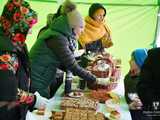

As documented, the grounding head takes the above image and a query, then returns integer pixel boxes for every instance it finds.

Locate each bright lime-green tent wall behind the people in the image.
[0,0,160,74]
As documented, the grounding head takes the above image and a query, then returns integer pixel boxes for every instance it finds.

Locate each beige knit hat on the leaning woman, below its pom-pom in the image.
[67,10,84,28]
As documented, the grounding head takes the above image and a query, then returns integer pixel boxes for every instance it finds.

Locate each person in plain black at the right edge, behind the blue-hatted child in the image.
[137,48,160,120]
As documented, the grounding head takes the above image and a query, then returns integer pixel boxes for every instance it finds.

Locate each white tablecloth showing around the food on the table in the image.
[26,78,132,120]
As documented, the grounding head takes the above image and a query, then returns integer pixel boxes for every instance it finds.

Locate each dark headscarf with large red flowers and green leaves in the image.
[0,0,37,46]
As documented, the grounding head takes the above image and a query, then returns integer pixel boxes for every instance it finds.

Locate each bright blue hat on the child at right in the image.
[132,49,147,68]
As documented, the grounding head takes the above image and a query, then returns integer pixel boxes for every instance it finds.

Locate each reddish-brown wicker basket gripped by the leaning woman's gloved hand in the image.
[88,54,121,91]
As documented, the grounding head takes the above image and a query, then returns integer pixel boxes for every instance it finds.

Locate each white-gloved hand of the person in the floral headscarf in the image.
[34,92,49,109]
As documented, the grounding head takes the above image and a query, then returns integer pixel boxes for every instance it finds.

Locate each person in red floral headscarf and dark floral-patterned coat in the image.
[0,0,48,120]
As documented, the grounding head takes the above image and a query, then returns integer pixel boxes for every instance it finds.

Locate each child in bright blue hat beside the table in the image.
[124,49,149,120]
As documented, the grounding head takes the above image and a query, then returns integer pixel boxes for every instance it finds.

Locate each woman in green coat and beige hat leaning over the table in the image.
[30,1,96,97]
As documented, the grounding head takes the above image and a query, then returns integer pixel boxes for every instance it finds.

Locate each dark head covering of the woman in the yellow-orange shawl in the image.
[89,3,106,18]
